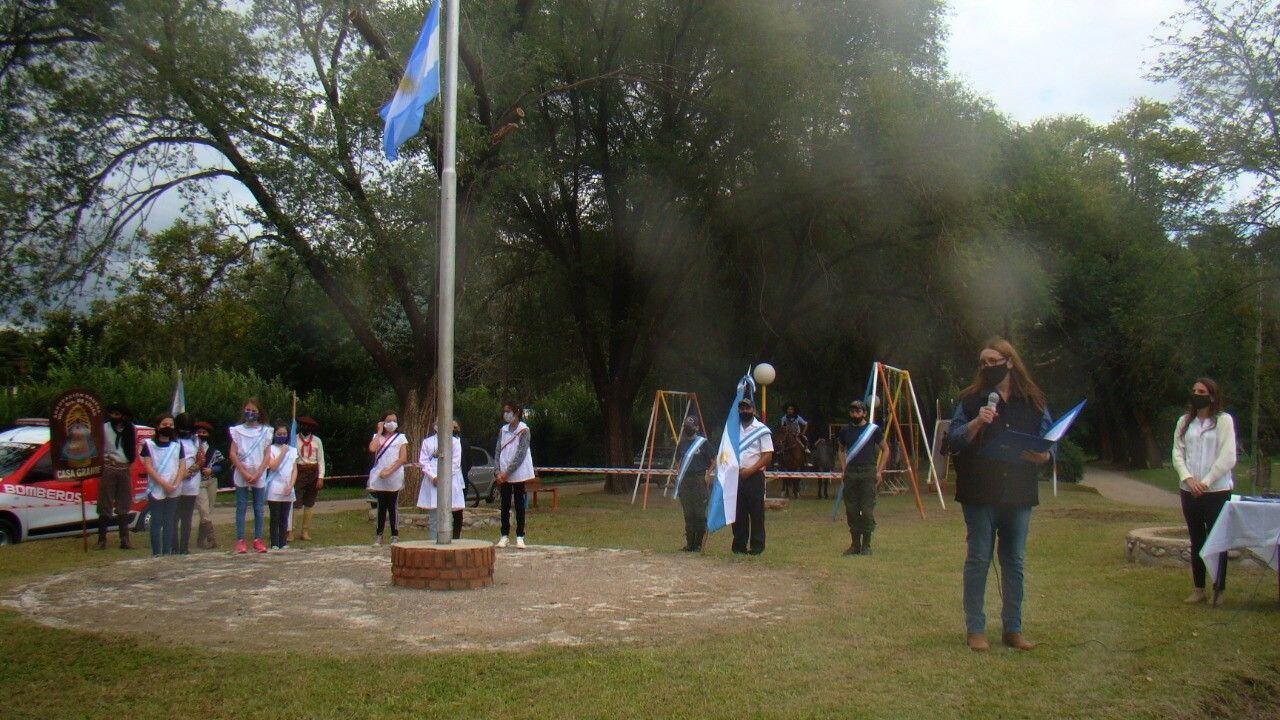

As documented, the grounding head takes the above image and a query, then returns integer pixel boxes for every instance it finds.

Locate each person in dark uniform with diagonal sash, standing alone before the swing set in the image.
[838,400,888,555]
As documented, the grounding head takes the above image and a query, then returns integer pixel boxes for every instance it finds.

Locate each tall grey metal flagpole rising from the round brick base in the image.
[435,0,462,544]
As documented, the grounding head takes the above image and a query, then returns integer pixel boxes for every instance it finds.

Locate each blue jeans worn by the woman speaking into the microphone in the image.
[961,505,1032,634]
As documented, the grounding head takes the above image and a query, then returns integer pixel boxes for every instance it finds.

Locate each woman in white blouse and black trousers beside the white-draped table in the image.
[1174,378,1235,605]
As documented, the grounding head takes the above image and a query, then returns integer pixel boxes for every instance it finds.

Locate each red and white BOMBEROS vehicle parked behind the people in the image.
[0,419,154,544]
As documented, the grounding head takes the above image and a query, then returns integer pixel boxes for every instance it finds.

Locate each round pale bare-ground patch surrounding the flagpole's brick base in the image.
[0,546,810,653]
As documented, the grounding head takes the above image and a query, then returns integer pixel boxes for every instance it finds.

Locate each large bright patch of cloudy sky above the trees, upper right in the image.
[947,0,1184,123]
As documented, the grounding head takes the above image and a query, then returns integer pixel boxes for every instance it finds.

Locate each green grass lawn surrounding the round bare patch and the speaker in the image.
[0,487,1280,720]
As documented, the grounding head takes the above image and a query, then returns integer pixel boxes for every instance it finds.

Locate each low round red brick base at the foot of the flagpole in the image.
[392,539,494,591]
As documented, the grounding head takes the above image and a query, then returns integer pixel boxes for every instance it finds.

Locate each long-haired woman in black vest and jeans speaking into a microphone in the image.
[947,337,1051,651]
